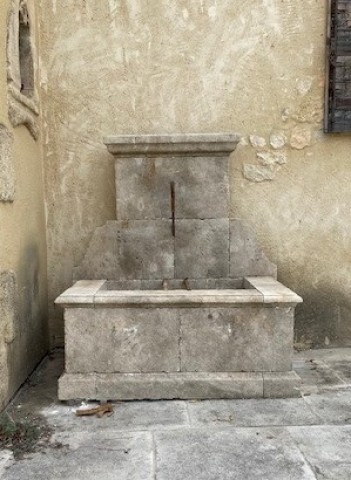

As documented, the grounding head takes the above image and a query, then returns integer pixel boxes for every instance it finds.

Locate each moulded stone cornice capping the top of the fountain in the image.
[103,133,241,157]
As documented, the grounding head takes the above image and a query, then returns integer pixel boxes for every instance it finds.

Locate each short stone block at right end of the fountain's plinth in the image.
[263,372,301,398]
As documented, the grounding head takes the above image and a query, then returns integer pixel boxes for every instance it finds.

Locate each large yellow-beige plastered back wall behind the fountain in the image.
[39,0,351,345]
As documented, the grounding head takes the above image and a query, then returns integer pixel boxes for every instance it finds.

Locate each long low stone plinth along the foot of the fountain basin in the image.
[58,372,300,401]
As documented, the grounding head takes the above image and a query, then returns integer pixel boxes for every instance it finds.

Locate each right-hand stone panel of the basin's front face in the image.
[181,306,294,372]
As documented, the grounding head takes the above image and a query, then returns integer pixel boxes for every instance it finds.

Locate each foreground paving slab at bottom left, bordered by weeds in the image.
[2,430,154,480]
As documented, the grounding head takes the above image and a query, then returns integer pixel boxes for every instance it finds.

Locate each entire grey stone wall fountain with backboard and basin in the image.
[56,134,302,400]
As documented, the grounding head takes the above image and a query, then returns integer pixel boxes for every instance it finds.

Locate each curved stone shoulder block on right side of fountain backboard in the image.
[230,219,277,278]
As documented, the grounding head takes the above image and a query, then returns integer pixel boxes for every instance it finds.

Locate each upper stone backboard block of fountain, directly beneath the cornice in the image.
[116,157,229,220]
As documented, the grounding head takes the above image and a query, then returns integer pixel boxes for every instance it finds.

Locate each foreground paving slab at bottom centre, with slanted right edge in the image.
[155,428,316,480]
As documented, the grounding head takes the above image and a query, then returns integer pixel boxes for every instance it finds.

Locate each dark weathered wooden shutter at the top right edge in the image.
[325,0,351,132]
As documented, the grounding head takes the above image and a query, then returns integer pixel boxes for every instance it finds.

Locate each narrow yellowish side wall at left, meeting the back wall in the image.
[0,0,47,409]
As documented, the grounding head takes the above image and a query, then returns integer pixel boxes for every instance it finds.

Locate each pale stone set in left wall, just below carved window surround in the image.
[0,124,15,202]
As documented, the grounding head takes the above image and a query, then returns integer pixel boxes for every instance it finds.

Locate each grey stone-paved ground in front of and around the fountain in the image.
[0,349,351,480]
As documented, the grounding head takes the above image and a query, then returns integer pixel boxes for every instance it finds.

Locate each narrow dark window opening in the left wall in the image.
[19,11,34,97]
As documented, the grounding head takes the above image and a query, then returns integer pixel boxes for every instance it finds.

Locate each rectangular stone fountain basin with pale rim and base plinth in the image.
[56,277,302,400]
